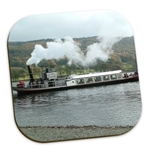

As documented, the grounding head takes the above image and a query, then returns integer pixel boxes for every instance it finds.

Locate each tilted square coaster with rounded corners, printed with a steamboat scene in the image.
[7,10,142,142]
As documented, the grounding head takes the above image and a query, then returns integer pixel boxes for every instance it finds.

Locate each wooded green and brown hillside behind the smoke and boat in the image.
[8,36,137,80]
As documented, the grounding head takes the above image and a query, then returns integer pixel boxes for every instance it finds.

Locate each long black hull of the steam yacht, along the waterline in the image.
[12,77,139,95]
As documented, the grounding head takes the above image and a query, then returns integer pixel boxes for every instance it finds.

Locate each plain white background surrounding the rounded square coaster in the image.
[0,0,150,150]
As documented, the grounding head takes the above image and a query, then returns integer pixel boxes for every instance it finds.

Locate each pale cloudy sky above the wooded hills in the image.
[8,10,133,41]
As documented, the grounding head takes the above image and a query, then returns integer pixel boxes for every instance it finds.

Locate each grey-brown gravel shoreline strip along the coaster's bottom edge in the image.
[18,125,134,143]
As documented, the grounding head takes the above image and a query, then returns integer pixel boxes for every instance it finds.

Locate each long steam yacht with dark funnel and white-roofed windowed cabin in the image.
[12,66,139,95]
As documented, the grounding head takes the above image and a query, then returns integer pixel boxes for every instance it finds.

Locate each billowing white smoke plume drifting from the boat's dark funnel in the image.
[26,37,117,67]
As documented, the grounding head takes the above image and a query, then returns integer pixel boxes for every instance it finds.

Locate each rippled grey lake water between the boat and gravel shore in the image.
[13,82,142,126]
